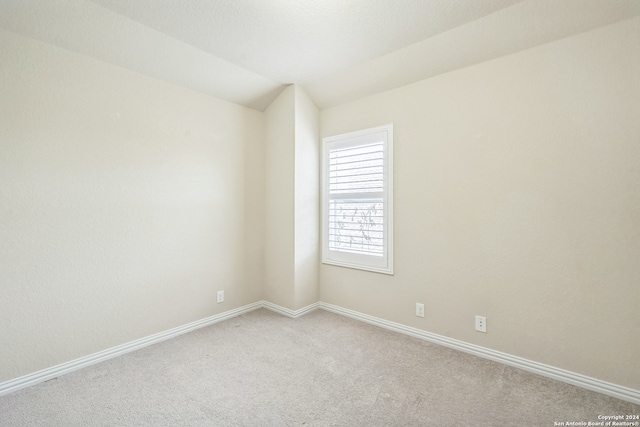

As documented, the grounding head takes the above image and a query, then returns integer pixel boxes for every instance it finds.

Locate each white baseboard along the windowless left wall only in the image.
[0,301,263,396]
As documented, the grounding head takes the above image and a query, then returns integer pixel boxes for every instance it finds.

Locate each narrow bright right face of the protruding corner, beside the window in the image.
[295,86,320,309]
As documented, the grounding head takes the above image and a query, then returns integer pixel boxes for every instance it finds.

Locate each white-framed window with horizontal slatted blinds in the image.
[322,125,393,274]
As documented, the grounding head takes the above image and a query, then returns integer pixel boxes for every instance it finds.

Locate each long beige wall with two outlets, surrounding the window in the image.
[320,18,640,389]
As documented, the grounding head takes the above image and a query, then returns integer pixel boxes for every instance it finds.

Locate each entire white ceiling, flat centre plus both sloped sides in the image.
[0,0,640,110]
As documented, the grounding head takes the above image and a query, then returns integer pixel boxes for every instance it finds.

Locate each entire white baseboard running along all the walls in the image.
[0,301,640,405]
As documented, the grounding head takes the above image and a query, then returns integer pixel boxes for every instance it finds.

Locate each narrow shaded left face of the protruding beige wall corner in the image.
[264,86,295,309]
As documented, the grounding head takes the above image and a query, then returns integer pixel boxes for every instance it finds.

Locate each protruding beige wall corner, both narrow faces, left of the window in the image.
[264,85,319,310]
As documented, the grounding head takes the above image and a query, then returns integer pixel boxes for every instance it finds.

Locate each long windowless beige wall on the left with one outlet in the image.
[0,31,262,381]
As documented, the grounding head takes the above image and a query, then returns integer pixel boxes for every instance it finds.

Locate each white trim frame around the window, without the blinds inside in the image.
[321,124,393,275]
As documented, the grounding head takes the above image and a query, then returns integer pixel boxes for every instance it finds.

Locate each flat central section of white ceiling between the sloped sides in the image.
[86,0,521,84]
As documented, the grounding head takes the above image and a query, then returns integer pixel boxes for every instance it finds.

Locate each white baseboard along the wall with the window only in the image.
[319,302,640,405]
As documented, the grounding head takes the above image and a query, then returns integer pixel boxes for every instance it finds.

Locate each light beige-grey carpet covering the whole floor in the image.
[0,309,640,427]
